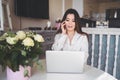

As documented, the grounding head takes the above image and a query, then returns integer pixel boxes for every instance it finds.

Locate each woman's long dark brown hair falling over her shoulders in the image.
[57,8,87,35]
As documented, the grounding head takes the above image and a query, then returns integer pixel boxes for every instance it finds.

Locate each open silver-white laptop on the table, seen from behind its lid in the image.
[46,50,85,74]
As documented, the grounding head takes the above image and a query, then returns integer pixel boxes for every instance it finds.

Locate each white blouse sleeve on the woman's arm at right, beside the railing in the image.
[81,36,89,63]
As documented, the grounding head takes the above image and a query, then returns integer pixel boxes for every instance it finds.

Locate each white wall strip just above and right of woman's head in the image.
[73,0,83,17]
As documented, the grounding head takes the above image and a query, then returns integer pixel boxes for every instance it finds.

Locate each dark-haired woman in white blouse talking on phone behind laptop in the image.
[52,9,88,60]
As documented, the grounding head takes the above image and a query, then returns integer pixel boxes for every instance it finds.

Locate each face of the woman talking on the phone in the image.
[65,14,75,31]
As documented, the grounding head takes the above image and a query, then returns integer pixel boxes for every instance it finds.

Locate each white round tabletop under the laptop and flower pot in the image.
[0,59,117,80]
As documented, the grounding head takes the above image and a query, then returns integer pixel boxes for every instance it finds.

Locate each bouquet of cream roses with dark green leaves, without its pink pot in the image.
[0,31,44,80]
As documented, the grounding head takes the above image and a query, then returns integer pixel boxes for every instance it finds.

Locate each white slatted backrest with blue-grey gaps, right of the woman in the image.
[83,28,120,79]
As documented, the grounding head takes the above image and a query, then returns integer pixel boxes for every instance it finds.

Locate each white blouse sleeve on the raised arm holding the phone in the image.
[52,34,67,51]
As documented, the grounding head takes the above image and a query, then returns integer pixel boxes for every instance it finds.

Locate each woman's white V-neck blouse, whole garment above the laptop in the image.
[52,32,88,61]
